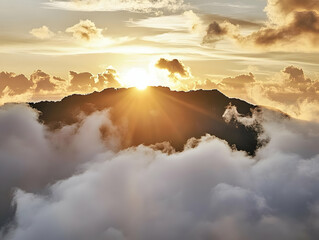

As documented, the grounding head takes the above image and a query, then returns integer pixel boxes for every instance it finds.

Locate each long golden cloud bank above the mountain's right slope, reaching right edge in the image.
[199,66,319,121]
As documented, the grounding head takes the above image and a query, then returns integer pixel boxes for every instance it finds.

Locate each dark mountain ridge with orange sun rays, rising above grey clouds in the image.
[30,87,258,154]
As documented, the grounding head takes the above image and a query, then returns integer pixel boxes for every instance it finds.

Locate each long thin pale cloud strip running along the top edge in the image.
[44,0,186,13]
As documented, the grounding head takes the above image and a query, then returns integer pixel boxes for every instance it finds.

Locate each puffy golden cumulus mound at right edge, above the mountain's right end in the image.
[254,66,319,120]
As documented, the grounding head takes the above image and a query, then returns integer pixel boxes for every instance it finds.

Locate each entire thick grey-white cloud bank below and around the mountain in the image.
[0,107,319,240]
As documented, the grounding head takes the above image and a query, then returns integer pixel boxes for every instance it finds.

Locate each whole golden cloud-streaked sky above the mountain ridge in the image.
[0,0,319,120]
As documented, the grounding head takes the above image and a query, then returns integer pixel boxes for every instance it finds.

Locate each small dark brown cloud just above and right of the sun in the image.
[155,58,190,78]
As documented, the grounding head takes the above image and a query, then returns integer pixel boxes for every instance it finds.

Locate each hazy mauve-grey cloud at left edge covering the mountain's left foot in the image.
[0,104,118,229]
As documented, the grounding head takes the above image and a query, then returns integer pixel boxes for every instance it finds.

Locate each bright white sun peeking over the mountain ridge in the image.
[123,68,151,90]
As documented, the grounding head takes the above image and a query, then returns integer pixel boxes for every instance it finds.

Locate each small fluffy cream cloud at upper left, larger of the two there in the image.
[66,19,103,41]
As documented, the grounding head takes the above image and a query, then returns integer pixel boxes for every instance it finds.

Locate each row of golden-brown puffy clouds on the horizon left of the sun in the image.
[0,67,122,105]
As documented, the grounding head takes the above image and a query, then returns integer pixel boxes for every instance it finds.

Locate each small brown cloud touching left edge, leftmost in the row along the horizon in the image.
[0,72,33,96]
